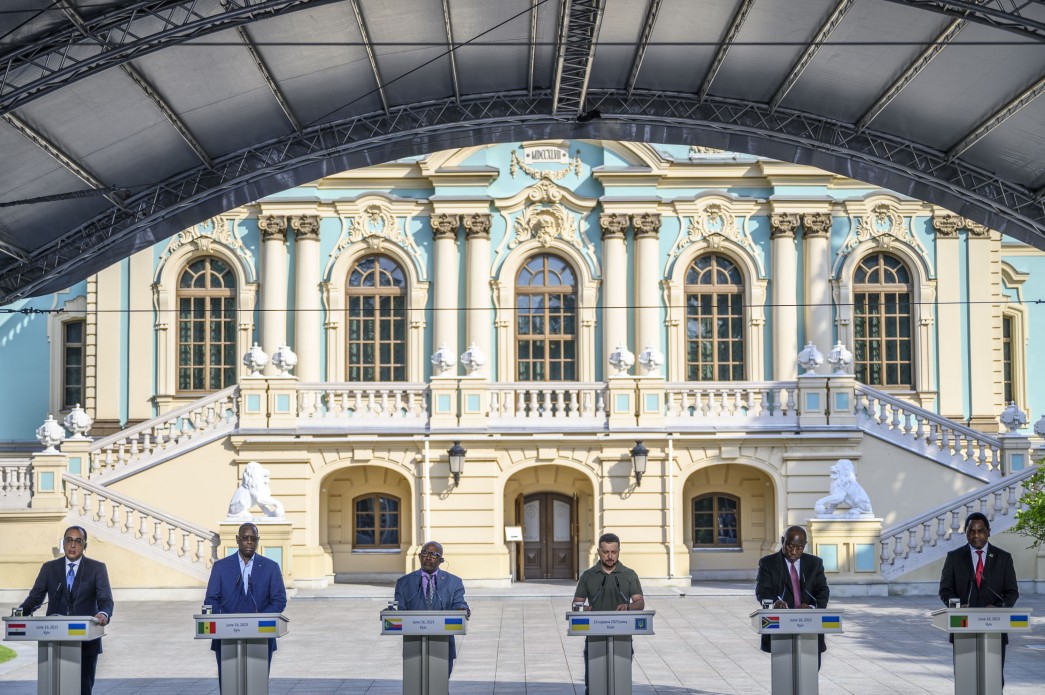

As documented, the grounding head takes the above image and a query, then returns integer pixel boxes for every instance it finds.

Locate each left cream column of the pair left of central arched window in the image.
[429,213,461,376]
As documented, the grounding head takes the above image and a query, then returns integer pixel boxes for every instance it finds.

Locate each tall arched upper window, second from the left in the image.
[345,256,407,383]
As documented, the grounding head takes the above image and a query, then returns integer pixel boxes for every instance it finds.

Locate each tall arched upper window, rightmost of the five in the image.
[853,253,913,388]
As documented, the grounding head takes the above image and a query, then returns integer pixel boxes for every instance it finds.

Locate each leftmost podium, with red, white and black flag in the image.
[3,616,106,695]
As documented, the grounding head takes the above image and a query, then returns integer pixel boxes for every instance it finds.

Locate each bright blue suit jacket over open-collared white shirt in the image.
[204,553,286,652]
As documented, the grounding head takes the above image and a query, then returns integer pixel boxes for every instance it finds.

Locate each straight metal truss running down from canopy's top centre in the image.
[552,0,606,117]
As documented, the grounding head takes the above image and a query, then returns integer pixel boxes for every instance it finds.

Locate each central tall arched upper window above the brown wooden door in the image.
[515,254,577,381]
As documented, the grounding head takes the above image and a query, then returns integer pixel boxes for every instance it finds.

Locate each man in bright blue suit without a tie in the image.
[204,522,286,681]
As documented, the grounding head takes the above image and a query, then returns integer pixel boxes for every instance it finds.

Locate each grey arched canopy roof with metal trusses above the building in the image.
[0,0,1045,303]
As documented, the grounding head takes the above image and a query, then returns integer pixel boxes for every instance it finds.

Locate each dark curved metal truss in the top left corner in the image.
[0,0,339,114]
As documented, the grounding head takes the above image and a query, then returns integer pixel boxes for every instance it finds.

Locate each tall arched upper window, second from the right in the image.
[686,254,745,381]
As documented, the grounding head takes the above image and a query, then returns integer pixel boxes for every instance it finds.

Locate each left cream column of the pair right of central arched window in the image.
[596,212,627,374]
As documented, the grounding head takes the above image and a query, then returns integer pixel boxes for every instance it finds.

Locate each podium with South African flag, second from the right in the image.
[749,608,845,695]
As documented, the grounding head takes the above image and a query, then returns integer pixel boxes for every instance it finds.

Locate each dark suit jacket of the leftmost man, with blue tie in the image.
[19,555,114,654]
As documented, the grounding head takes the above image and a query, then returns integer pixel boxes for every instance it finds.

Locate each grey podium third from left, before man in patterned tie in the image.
[381,610,468,695]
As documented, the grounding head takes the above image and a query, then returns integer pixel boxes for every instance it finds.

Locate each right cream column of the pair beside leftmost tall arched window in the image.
[291,215,322,381]
